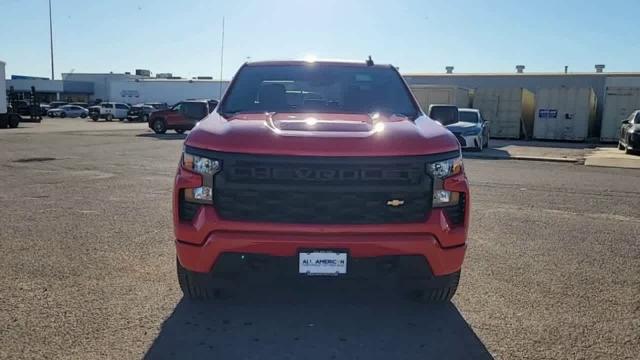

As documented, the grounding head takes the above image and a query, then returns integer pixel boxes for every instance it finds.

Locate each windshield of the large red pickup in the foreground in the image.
[220,64,418,117]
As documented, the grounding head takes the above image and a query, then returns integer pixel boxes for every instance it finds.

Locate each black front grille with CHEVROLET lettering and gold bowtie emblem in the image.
[180,148,457,224]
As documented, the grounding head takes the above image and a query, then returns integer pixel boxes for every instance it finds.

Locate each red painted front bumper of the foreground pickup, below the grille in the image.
[173,168,470,276]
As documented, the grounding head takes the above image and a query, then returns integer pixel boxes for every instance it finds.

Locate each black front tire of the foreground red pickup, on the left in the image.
[176,258,224,300]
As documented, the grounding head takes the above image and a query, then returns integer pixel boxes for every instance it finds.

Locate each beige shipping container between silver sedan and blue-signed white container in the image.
[473,88,535,139]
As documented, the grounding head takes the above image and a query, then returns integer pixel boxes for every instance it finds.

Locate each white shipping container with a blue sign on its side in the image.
[533,87,596,141]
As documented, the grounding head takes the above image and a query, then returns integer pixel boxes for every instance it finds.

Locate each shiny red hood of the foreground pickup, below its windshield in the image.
[185,112,459,156]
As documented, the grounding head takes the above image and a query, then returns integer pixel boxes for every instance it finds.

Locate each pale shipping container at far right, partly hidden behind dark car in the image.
[600,84,640,142]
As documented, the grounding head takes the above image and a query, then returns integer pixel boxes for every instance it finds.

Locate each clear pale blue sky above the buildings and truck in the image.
[0,0,640,78]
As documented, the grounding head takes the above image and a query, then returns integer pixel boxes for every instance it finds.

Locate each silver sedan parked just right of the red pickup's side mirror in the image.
[447,109,490,151]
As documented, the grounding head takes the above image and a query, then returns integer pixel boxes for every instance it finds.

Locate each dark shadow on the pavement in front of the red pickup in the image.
[145,281,492,360]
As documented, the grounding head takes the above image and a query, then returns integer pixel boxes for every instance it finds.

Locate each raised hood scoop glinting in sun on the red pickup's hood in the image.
[266,113,383,136]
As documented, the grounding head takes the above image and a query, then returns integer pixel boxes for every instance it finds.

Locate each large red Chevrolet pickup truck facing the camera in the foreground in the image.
[173,61,470,301]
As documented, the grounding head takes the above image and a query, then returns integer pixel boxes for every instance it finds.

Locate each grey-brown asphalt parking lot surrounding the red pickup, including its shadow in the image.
[0,119,640,359]
